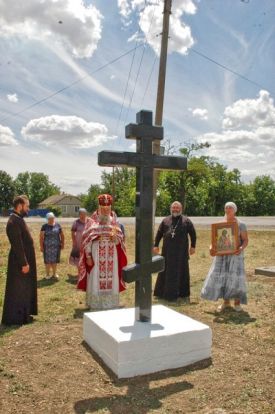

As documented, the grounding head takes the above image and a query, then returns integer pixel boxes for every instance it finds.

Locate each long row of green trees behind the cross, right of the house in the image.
[81,142,275,217]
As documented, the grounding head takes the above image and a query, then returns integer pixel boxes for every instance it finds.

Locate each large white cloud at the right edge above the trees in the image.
[198,91,275,175]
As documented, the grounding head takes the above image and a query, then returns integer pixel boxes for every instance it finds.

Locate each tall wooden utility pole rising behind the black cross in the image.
[153,0,172,218]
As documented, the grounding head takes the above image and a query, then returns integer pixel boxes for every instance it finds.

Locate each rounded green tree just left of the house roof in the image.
[14,171,60,208]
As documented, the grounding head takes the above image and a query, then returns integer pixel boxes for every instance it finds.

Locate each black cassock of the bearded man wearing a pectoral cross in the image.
[154,215,196,301]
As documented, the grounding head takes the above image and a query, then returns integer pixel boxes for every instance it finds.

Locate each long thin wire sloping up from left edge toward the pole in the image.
[0,42,145,122]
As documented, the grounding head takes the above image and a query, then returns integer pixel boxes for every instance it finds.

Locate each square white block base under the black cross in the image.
[83,305,212,378]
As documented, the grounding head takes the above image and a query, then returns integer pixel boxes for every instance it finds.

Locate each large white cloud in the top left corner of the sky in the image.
[0,0,102,58]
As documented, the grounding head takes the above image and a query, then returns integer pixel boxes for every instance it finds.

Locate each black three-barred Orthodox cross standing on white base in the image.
[98,110,187,322]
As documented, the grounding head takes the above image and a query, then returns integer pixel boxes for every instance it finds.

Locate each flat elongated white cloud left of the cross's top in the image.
[21,115,115,149]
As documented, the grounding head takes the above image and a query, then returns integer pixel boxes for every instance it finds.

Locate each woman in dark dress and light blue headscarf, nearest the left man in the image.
[40,212,64,280]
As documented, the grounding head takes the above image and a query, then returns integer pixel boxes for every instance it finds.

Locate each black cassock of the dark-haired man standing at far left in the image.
[2,212,37,325]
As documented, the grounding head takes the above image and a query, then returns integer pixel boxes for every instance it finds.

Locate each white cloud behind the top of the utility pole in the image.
[118,0,196,54]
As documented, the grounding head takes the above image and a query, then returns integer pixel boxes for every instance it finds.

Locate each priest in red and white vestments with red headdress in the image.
[77,194,127,310]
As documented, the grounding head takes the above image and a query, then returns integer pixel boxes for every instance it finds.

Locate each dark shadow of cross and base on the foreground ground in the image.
[74,342,209,414]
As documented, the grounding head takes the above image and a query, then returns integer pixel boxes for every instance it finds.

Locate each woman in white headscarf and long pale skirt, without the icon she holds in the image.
[201,201,248,312]
